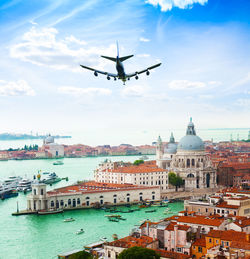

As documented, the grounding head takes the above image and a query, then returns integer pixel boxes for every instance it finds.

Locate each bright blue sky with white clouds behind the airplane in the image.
[0,0,250,145]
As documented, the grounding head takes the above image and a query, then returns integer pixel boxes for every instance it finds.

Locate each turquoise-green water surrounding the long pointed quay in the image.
[0,156,183,259]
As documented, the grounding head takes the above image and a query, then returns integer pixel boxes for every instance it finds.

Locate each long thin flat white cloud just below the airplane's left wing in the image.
[58,86,112,97]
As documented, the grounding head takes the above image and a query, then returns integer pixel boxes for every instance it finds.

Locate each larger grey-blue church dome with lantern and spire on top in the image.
[178,118,204,151]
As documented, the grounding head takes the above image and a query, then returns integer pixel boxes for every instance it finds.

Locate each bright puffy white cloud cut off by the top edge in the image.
[146,0,208,12]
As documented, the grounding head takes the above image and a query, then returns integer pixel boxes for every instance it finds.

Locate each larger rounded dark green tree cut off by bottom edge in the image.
[118,246,160,259]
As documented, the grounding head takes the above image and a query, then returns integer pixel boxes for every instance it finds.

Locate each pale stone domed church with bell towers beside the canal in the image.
[156,118,216,190]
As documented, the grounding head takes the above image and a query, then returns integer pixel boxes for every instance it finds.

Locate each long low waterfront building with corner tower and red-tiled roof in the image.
[27,181,160,212]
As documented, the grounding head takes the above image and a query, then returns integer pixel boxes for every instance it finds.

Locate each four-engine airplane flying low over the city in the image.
[80,42,161,85]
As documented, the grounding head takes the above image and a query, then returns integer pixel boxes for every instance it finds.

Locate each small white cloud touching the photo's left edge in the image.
[0,80,35,96]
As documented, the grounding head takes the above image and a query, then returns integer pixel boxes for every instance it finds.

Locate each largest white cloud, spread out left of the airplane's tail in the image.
[10,27,116,72]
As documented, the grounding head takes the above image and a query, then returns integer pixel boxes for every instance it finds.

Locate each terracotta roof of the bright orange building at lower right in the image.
[207,230,247,242]
